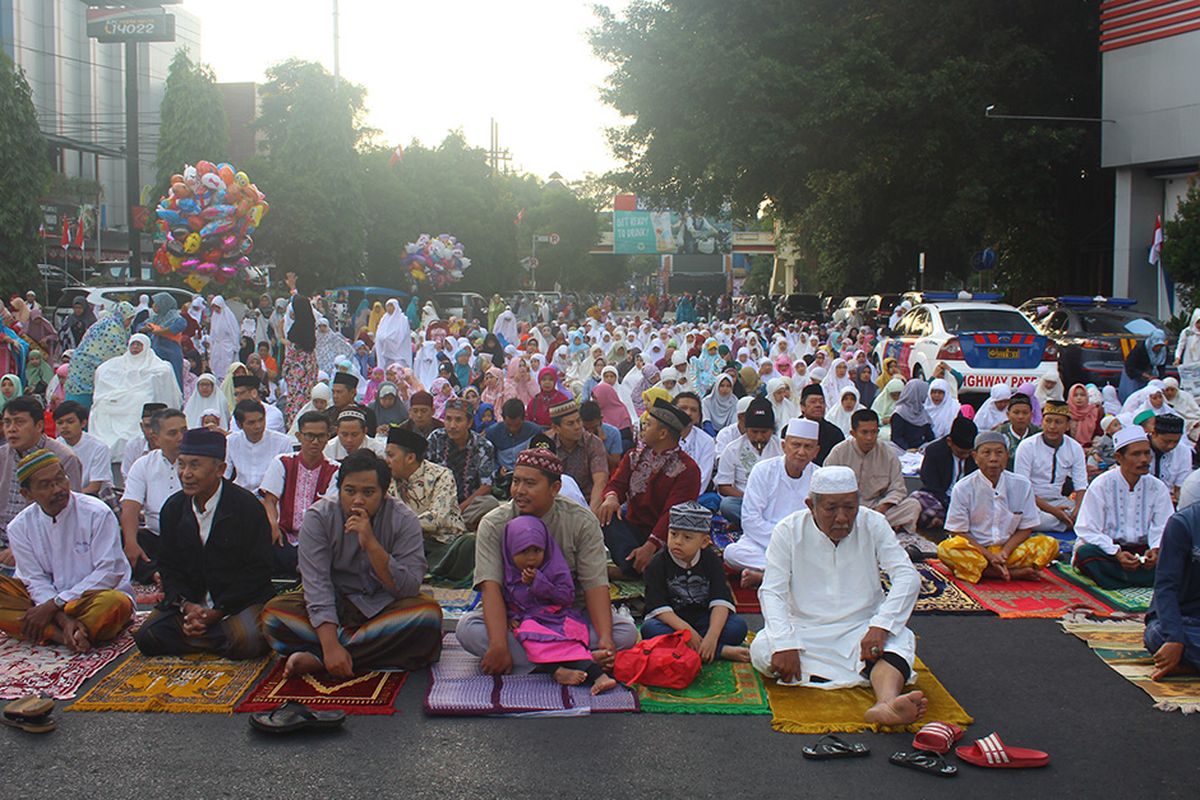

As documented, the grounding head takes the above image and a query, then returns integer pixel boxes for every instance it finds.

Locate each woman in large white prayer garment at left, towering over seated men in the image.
[89,331,182,455]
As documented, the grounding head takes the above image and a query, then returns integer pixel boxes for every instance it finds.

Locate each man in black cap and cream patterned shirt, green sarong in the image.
[386,426,475,583]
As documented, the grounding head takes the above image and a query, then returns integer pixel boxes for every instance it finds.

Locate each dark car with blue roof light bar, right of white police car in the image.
[1026,299,1177,386]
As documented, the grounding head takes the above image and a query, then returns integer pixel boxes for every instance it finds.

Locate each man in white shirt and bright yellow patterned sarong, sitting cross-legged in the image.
[937,431,1058,583]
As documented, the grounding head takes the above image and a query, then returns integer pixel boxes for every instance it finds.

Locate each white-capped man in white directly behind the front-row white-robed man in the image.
[725,419,821,588]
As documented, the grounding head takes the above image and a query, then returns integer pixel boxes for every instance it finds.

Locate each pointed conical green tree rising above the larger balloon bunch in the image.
[151,49,229,196]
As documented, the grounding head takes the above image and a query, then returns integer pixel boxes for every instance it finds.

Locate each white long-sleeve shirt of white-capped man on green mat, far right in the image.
[1075,467,1175,555]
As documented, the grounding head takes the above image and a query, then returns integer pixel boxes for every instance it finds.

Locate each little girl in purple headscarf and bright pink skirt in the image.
[504,517,617,694]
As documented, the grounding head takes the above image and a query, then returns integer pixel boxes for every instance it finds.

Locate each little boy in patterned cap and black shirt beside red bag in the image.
[642,503,750,663]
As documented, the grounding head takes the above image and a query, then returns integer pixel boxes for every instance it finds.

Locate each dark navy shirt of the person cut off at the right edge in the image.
[1146,504,1200,644]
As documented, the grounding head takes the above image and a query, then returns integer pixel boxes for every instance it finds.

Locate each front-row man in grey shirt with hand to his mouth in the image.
[262,449,442,678]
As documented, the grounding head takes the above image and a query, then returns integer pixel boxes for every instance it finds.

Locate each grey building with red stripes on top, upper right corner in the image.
[1100,8,1200,317]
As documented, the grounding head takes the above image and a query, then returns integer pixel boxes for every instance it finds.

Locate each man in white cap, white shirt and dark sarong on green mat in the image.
[1073,425,1175,589]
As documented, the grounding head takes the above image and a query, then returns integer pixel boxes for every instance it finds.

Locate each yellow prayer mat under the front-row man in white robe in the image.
[762,658,974,733]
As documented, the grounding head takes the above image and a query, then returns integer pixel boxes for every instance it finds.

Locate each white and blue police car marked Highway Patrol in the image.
[874,291,1058,393]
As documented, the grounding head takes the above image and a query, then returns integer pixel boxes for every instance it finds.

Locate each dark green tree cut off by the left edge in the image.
[0,53,49,291]
